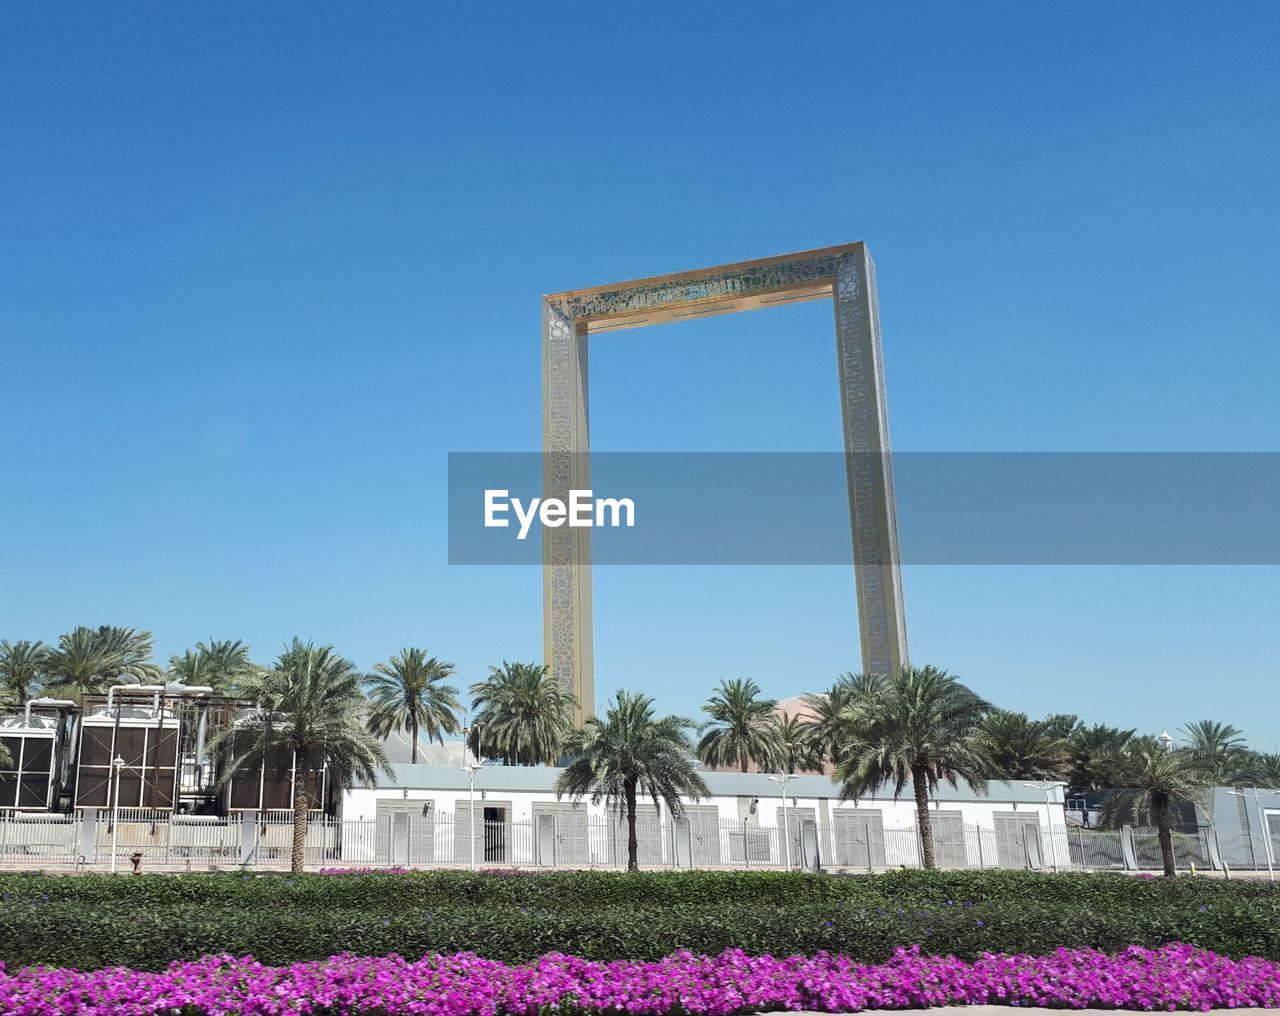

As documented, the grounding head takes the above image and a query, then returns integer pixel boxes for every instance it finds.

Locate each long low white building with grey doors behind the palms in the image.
[340,749,1069,870]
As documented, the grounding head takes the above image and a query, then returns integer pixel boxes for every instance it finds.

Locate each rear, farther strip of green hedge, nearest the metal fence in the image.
[0,870,1280,914]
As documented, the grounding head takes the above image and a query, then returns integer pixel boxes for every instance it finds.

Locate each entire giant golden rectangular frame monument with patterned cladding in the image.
[543,243,908,726]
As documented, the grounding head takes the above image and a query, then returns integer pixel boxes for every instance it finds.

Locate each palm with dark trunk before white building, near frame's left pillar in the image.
[556,691,710,871]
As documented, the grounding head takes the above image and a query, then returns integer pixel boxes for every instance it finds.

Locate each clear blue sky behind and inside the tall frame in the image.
[0,3,1280,750]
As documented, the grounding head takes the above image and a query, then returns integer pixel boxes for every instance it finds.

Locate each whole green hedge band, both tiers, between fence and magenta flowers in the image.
[0,871,1280,969]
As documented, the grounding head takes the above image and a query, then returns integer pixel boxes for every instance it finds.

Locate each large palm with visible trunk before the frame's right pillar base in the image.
[836,667,991,868]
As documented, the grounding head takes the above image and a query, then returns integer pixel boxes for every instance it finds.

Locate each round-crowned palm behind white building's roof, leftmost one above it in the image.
[367,646,462,765]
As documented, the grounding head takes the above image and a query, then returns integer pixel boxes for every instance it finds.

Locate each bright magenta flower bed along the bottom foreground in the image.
[0,944,1280,1016]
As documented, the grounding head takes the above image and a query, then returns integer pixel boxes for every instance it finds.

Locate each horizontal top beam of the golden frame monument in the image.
[543,242,863,334]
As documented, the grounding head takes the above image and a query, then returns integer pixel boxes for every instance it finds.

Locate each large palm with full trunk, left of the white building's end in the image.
[210,639,390,874]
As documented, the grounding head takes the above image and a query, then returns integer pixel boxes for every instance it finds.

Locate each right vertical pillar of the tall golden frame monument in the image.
[832,247,910,674]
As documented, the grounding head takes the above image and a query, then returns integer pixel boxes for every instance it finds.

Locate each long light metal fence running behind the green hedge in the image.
[0,809,1280,871]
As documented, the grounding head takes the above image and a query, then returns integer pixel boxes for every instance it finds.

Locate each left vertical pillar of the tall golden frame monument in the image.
[543,302,595,727]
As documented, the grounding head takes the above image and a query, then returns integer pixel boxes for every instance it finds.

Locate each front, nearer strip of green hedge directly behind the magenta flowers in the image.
[0,900,1280,970]
